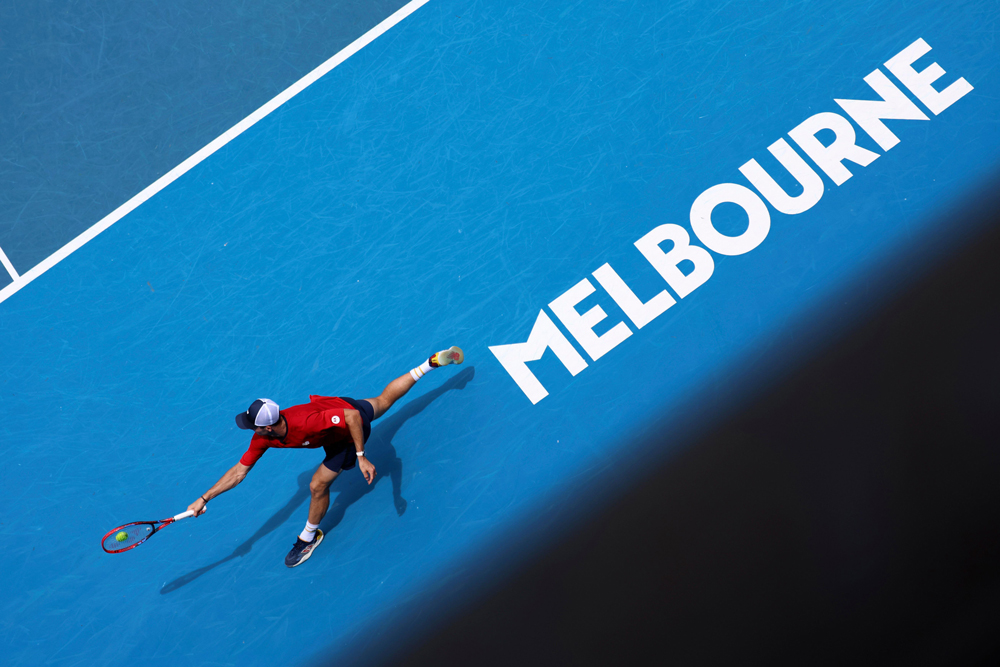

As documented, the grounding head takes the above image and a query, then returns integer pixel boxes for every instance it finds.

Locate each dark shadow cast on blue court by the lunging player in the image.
[160,366,476,595]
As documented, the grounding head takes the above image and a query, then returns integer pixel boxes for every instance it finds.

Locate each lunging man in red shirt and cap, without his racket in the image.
[188,347,465,567]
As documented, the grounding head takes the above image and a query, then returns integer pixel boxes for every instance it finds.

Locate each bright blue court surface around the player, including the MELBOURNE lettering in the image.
[0,0,1000,665]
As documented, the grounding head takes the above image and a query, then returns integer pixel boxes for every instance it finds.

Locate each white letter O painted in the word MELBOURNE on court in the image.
[691,183,771,255]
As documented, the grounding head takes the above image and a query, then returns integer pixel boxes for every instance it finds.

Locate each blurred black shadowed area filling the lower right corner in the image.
[340,181,1000,667]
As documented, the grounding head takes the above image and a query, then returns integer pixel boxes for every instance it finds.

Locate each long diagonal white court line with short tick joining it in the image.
[0,0,430,303]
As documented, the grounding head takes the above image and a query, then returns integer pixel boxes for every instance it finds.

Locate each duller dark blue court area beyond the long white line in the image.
[0,0,404,282]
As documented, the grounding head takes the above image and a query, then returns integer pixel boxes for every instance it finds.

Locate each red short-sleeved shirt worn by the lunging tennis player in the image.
[240,396,354,466]
